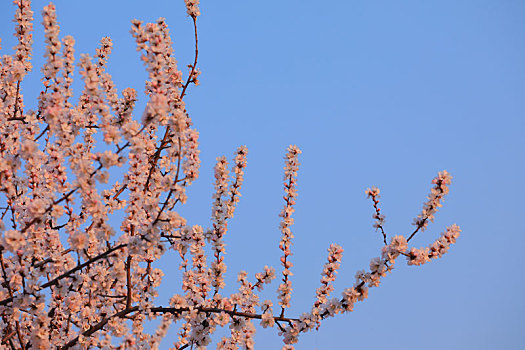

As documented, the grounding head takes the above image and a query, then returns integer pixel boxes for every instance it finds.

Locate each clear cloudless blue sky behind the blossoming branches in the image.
[0,0,525,350]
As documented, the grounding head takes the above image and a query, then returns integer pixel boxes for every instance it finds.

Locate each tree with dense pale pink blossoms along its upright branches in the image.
[0,0,460,350]
